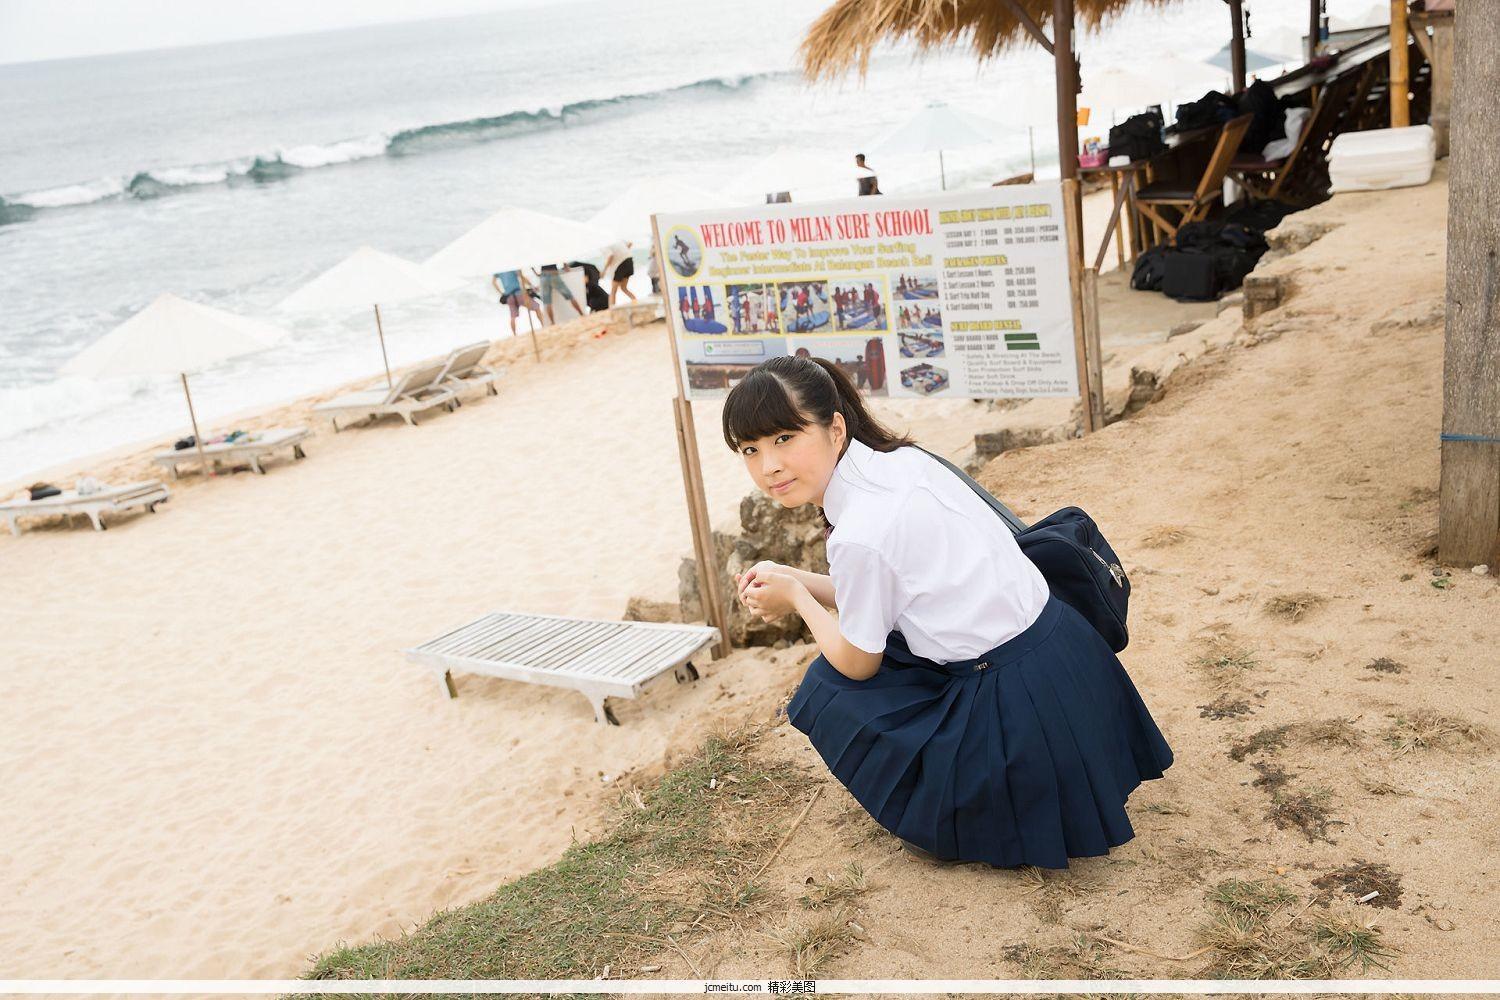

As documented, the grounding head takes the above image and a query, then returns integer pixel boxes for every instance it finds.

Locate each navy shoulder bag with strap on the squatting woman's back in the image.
[923,448,1130,652]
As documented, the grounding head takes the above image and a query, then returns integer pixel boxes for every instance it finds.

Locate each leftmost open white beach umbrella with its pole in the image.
[63,294,287,472]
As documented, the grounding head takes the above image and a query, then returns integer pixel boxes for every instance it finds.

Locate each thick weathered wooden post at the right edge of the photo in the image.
[1437,3,1500,567]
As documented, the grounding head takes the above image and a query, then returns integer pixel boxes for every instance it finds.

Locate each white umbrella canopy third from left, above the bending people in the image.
[428,208,615,277]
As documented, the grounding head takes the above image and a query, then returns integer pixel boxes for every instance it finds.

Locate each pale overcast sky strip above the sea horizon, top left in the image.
[0,0,543,63]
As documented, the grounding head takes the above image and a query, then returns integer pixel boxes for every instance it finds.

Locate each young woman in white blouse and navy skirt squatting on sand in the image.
[723,357,1172,868]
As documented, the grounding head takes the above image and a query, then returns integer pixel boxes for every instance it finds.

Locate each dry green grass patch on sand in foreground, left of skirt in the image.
[308,730,809,979]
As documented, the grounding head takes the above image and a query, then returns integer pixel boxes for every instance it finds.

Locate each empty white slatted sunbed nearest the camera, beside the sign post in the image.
[405,612,719,726]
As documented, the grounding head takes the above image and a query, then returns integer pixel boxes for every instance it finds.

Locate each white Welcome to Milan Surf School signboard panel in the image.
[657,184,1079,399]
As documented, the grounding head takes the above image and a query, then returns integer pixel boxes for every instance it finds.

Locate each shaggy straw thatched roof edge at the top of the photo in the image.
[801,0,1176,79]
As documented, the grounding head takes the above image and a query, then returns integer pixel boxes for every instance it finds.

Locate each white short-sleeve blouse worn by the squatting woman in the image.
[824,441,1047,663]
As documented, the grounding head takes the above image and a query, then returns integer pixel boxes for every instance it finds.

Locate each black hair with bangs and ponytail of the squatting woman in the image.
[723,357,912,451]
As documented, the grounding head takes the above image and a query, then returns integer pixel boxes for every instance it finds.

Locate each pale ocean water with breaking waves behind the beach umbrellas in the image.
[0,0,1278,481]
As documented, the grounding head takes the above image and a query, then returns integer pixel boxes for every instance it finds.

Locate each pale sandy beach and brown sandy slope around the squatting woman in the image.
[0,166,1500,978]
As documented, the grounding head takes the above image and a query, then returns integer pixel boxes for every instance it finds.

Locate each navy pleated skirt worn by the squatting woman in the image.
[786,597,1172,868]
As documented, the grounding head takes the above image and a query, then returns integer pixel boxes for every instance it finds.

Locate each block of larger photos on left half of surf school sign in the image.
[681,275,900,396]
